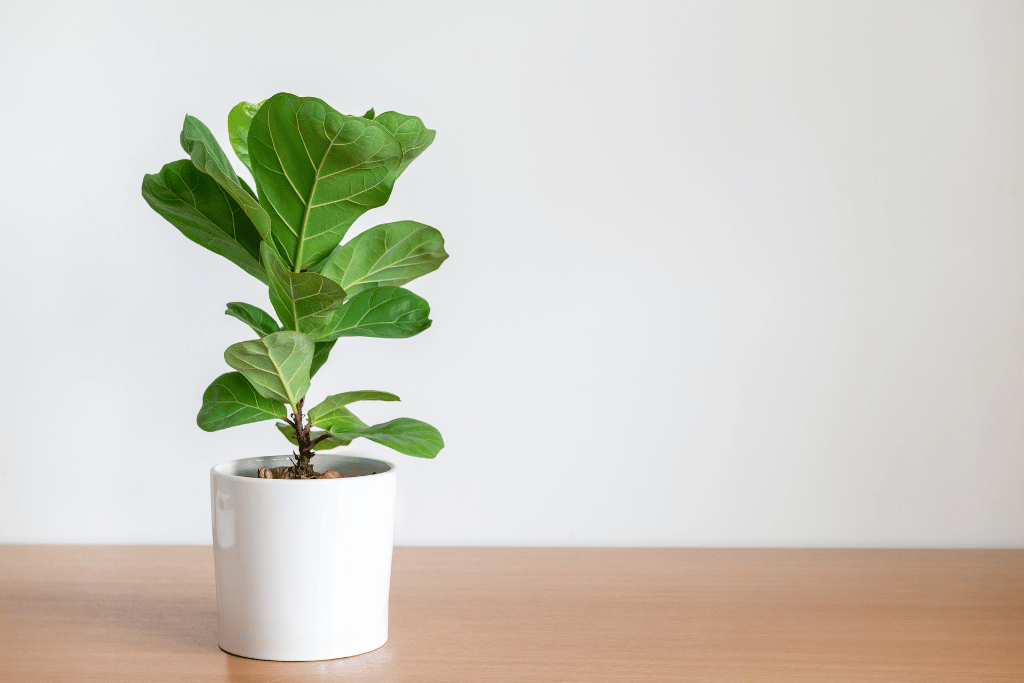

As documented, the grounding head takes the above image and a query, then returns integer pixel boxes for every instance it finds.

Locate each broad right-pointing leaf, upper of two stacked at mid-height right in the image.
[321,220,447,296]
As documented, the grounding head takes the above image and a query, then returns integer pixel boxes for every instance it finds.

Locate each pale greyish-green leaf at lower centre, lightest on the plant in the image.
[224,331,313,408]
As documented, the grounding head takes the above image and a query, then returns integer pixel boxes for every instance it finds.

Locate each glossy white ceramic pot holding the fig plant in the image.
[210,454,397,661]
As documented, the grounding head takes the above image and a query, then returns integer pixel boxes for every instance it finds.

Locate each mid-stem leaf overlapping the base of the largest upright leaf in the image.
[262,242,345,340]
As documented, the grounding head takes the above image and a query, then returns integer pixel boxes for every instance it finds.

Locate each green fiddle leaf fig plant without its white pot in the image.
[142,92,447,478]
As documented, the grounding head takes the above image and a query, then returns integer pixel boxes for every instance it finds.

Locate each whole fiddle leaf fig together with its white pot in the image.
[142,93,447,660]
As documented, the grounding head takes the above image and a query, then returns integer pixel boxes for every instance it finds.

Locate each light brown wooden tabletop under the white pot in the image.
[0,546,1024,683]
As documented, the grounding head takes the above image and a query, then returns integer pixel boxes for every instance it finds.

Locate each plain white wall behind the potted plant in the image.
[0,0,1024,547]
